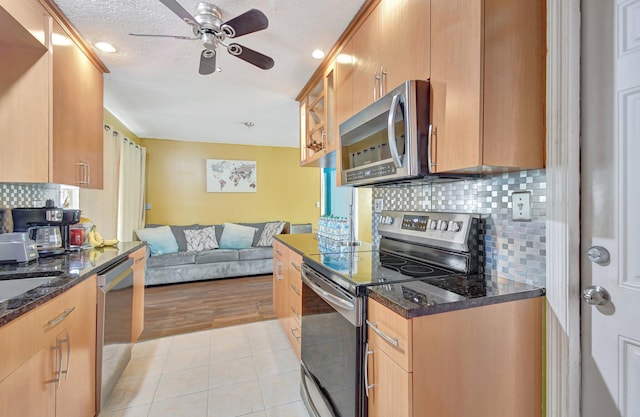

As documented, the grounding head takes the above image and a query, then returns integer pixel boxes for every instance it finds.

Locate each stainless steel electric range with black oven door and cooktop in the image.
[301,211,480,417]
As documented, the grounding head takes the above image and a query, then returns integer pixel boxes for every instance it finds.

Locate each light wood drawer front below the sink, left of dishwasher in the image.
[0,279,96,380]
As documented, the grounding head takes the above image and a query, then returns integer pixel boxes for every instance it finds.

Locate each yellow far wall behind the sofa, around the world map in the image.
[140,139,320,225]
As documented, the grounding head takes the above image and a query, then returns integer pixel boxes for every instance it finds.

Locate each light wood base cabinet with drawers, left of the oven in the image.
[273,241,302,359]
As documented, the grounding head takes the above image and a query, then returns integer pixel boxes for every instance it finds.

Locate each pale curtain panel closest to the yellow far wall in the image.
[118,138,147,242]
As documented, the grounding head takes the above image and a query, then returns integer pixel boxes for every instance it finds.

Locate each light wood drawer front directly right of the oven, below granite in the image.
[367,299,413,372]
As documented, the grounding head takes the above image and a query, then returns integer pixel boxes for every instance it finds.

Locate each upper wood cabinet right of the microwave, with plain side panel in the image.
[431,0,546,173]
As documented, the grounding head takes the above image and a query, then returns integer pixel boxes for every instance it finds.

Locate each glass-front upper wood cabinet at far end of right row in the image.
[300,64,339,167]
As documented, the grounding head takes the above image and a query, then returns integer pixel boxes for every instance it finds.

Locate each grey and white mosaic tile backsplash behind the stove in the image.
[372,170,547,286]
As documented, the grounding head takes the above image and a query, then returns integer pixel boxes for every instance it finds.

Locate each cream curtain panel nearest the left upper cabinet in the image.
[79,125,122,239]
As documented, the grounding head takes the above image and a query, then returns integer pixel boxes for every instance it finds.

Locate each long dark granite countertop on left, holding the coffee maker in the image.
[0,242,145,327]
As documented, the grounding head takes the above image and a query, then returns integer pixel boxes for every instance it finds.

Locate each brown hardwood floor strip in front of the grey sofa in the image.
[140,275,275,340]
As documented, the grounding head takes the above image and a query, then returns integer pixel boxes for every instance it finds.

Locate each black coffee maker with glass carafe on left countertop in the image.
[11,200,81,256]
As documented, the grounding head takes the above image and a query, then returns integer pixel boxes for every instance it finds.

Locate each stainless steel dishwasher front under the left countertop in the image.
[96,259,133,412]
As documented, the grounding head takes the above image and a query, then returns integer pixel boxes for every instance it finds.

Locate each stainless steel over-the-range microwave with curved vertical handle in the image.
[339,80,431,186]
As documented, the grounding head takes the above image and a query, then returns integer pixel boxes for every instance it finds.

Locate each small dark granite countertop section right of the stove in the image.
[367,274,545,319]
